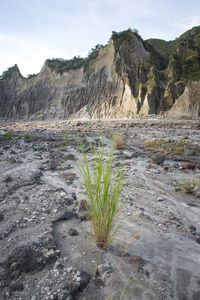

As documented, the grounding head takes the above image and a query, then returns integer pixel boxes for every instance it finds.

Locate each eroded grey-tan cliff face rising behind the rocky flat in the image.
[0,26,200,119]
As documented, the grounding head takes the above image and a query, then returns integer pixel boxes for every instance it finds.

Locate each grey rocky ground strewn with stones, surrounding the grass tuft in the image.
[0,118,200,300]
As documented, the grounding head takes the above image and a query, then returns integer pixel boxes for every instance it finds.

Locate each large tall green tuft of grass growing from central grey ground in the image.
[79,138,125,249]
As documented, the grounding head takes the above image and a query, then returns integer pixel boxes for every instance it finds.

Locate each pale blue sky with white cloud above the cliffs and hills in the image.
[0,0,200,76]
